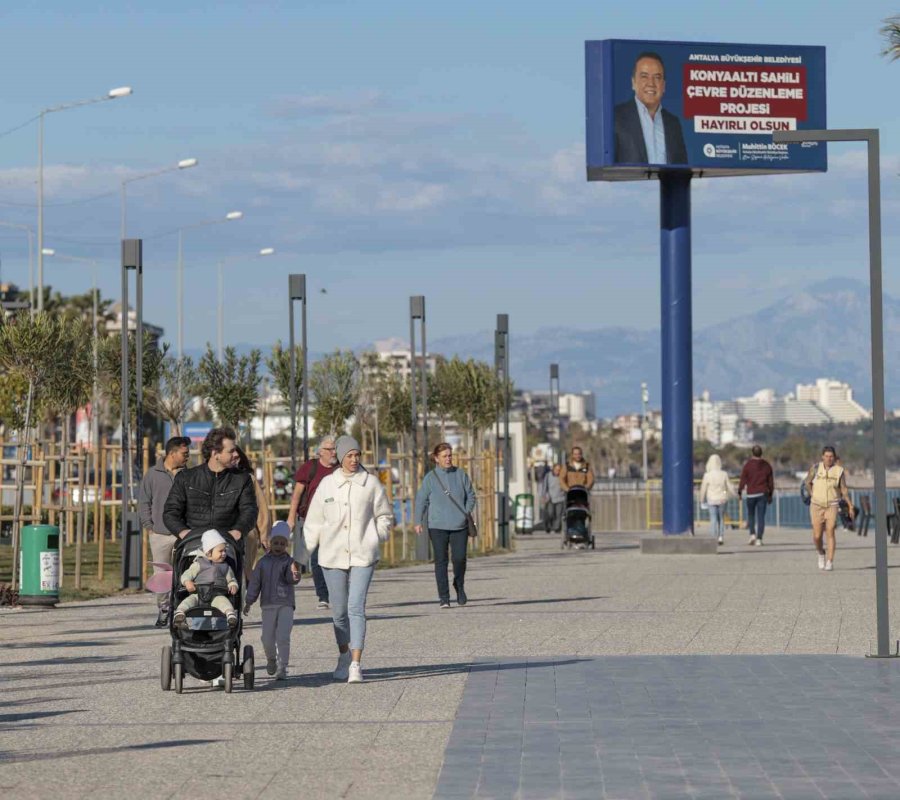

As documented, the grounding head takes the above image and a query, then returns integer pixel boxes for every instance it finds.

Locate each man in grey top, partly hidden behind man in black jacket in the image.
[138,436,191,628]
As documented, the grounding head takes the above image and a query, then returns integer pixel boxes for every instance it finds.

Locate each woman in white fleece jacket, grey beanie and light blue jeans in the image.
[303,436,394,683]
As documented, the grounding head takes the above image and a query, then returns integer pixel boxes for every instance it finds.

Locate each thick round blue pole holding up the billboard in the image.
[659,175,694,534]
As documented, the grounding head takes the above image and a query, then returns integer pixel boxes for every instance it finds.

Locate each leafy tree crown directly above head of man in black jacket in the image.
[199,344,262,429]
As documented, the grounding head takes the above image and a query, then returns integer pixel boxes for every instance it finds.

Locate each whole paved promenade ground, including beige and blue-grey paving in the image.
[0,530,900,798]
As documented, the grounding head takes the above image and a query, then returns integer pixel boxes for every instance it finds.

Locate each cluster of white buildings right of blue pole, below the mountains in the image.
[693,378,871,446]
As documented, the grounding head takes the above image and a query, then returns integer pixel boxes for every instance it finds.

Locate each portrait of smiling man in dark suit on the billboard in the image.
[615,51,688,164]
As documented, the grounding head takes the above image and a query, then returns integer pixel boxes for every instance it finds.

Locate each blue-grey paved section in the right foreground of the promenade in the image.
[435,655,900,800]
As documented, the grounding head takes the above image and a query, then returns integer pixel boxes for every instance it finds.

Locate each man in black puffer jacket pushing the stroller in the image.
[163,428,259,541]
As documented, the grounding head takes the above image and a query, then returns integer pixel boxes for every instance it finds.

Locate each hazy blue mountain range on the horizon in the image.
[429,280,900,417]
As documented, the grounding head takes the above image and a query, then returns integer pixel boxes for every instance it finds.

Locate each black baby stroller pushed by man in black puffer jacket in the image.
[160,529,255,694]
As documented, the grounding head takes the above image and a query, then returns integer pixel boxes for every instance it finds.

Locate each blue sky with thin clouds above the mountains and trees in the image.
[0,0,900,351]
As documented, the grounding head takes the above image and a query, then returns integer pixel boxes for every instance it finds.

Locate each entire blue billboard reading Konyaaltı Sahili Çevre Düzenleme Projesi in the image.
[585,39,828,180]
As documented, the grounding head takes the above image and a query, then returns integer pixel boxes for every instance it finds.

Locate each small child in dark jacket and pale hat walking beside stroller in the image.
[244,520,300,681]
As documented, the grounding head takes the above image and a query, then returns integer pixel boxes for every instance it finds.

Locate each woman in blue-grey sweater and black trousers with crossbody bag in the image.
[416,442,475,608]
